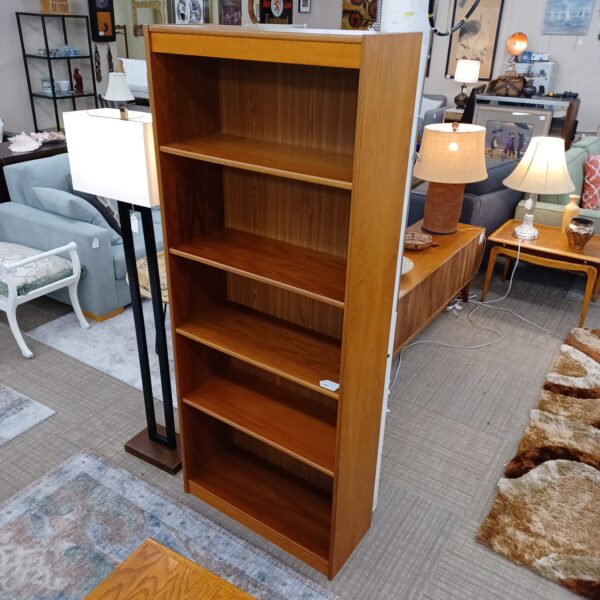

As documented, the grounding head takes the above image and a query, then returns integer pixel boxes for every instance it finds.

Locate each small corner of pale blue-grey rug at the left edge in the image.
[0,383,55,446]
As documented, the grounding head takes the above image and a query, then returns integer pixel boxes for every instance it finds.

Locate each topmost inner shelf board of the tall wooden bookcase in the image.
[160,133,353,190]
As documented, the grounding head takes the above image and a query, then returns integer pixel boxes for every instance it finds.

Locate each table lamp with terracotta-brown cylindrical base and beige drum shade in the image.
[413,123,487,234]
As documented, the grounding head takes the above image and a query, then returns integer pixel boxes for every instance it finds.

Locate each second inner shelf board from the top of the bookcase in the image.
[171,228,346,308]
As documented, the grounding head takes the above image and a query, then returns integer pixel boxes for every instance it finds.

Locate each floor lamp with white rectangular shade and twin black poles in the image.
[63,106,181,473]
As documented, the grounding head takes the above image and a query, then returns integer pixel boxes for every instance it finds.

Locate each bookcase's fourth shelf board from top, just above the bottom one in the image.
[183,369,336,477]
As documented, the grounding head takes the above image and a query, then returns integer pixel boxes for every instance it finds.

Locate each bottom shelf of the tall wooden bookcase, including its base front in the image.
[188,447,331,573]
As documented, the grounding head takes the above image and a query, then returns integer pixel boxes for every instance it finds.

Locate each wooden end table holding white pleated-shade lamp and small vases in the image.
[481,219,600,327]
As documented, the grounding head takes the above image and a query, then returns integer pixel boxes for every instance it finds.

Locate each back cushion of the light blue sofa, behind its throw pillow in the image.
[4,154,70,209]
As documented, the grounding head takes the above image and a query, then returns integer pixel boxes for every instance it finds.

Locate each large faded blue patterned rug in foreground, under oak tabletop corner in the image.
[0,452,334,600]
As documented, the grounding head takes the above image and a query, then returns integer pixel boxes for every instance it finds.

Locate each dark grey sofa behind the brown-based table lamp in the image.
[408,160,523,235]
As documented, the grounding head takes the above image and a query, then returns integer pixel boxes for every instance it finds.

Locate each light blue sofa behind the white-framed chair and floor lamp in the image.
[0,154,163,320]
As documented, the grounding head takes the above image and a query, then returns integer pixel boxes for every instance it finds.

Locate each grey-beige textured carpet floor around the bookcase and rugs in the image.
[0,267,600,600]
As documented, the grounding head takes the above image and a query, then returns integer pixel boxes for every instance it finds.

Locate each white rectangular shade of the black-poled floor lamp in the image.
[63,108,159,206]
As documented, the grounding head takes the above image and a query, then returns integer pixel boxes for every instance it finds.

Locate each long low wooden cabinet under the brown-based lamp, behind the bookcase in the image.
[394,221,485,353]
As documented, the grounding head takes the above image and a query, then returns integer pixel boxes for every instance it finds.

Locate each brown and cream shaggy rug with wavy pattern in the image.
[477,328,600,600]
